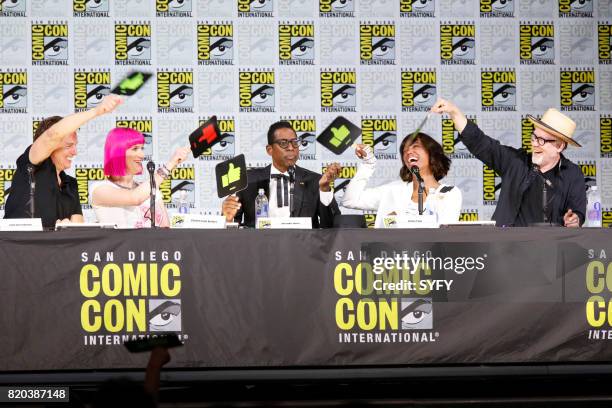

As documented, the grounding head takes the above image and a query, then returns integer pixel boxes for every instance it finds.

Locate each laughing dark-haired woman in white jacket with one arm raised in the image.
[342,133,461,228]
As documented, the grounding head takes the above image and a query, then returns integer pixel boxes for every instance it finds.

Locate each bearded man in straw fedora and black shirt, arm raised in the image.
[431,99,586,227]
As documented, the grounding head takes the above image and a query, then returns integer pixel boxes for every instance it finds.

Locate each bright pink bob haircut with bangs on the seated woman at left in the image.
[104,128,144,177]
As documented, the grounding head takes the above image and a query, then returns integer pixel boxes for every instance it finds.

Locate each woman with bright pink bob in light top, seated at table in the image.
[91,128,190,228]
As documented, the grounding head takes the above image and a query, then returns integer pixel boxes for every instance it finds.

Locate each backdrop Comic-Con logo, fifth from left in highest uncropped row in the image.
[359,24,395,65]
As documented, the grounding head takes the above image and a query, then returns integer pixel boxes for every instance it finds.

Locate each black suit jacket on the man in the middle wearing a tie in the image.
[234,165,340,228]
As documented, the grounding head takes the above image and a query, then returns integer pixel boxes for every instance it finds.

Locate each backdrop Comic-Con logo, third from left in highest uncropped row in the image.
[197,22,234,65]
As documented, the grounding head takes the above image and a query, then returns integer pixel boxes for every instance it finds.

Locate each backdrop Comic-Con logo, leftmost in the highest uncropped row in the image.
[32,22,68,65]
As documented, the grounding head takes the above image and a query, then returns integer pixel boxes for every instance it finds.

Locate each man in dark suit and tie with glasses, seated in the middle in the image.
[222,121,340,228]
